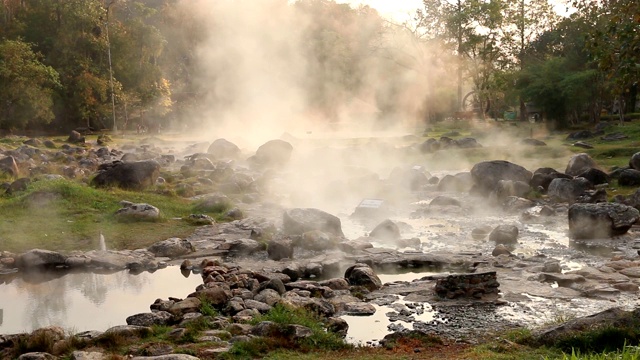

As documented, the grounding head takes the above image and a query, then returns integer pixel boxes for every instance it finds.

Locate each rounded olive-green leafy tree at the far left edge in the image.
[0,40,60,129]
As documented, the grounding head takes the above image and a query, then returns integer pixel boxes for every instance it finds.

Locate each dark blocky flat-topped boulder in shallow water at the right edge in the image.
[569,203,640,239]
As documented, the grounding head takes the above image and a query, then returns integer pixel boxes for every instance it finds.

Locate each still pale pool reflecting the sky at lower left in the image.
[0,267,202,334]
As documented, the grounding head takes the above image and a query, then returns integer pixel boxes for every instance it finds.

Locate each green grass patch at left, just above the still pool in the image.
[0,180,228,252]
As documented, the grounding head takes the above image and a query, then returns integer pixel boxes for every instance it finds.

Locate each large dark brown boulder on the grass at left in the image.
[91,160,160,190]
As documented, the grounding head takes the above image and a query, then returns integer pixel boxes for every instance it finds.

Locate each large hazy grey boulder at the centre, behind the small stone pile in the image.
[282,208,344,237]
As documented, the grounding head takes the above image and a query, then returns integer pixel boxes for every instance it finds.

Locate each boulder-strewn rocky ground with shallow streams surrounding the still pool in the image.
[0,129,640,359]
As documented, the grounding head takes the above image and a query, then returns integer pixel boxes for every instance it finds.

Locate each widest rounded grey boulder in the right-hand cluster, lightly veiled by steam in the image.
[471,160,533,195]
